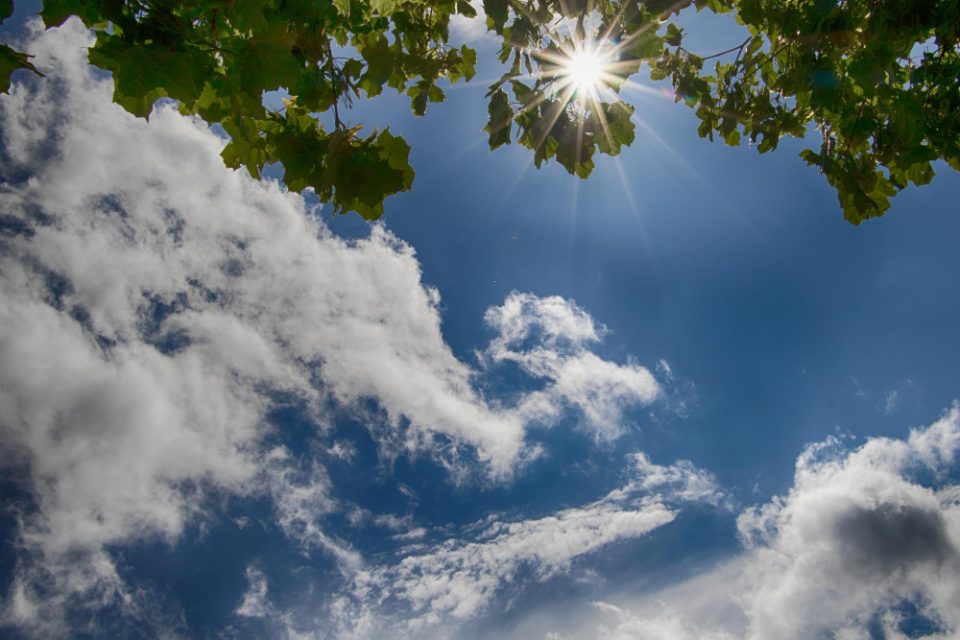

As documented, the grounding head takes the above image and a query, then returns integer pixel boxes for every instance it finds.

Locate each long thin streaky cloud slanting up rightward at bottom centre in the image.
[237,454,725,638]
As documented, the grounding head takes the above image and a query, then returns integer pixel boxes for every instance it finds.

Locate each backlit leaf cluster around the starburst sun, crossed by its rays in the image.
[484,0,663,178]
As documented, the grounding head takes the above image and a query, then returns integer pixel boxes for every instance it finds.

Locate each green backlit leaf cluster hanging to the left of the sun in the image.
[41,0,476,219]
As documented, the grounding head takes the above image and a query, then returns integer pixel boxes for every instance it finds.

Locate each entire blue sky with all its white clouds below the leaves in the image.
[0,7,960,640]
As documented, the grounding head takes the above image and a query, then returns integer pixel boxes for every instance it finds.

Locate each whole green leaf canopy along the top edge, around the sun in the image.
[0,0,960,224]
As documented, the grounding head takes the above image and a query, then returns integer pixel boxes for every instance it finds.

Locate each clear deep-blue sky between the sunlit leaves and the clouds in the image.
[331,17,960,491]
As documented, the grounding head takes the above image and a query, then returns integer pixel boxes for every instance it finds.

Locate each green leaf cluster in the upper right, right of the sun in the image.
[652,0,960,224]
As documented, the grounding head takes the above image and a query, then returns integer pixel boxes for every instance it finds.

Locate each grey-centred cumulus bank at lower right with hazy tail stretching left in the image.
[532,405,960,640]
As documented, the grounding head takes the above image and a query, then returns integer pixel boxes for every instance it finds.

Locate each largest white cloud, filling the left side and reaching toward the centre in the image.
[0,21,659,635]
